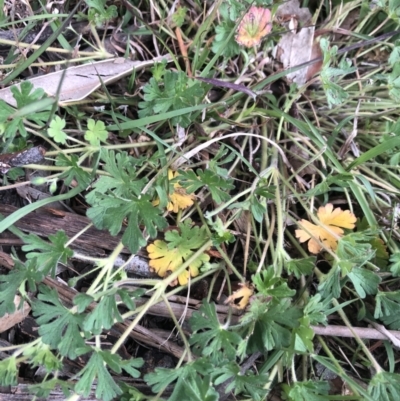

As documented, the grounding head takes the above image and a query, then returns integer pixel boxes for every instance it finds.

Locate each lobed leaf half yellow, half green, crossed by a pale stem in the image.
[147,219,210,285]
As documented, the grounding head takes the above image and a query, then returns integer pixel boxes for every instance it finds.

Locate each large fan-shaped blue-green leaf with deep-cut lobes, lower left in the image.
[32,286,85,359]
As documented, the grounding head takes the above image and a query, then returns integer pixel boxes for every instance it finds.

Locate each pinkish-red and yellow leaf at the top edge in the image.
[235,6,272,47]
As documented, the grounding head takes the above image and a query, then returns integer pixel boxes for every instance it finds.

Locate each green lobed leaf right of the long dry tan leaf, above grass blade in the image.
[139,71,205,128]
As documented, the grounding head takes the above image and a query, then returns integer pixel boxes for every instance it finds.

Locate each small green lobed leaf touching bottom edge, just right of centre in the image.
[214,362,269,401]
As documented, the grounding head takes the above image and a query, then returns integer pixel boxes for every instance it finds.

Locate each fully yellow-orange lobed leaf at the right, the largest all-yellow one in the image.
[296,203,357,254]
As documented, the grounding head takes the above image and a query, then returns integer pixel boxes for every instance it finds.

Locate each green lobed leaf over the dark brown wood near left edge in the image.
[22,230,74,277]
